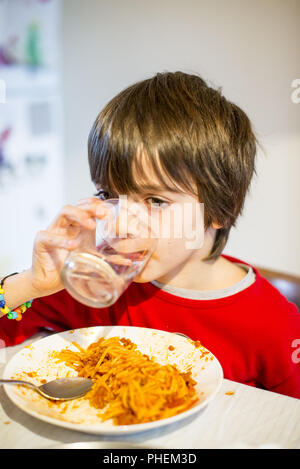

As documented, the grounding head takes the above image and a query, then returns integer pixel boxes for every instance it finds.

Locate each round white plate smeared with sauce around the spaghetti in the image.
[3,326,223,435]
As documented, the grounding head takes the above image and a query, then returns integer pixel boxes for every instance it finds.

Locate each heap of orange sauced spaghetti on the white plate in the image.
[56,337,198,425]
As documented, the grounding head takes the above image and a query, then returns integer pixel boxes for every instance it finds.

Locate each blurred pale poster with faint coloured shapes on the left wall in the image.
[0,0,63,274]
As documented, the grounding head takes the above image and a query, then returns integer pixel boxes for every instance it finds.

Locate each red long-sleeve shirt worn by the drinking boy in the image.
[0,255,300,399]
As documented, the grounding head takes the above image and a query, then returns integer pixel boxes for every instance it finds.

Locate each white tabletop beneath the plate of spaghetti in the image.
[0,332,300,449]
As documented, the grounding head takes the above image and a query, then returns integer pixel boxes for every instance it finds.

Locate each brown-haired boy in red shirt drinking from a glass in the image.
[0,72,300,398]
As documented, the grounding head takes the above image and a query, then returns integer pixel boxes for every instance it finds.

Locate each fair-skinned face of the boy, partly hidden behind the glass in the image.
[97,159,215,283]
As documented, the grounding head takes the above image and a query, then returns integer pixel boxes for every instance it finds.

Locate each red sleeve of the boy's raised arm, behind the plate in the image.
[0,290,110,347]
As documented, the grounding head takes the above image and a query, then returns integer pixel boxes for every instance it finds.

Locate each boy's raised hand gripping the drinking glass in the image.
[31,197,106,296]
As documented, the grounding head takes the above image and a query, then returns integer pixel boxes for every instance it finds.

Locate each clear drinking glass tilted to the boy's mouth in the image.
[61,199,157,308]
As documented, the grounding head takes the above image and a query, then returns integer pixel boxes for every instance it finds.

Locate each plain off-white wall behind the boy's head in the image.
[63,0,300,275]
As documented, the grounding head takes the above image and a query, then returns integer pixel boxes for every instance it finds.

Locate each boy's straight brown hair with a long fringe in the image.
[88,72,258,259]
